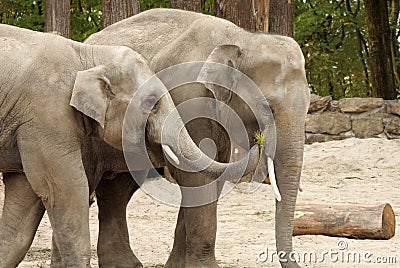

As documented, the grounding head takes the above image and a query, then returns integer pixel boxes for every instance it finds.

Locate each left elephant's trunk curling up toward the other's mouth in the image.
[162,120,259,180]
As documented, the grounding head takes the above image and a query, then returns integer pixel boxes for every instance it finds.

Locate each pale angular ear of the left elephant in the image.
[69,65,111,128]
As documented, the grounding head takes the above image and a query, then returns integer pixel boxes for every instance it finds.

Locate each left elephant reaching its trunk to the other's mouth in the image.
[0,24,259,267]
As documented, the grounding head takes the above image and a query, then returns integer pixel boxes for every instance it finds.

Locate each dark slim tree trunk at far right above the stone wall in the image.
[364,0,397,99]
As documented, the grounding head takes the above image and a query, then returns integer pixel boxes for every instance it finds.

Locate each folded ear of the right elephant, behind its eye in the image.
[197,45,243,103]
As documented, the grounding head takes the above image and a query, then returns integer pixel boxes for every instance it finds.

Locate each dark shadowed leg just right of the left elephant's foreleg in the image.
[96,173,141,268]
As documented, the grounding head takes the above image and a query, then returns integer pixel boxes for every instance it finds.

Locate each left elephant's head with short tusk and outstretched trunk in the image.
[70,46,258,178]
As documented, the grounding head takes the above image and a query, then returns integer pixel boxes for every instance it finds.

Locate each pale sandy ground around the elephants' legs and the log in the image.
[1,139,400,268]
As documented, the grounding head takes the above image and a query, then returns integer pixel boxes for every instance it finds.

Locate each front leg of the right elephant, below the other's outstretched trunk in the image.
[166,169,219,268]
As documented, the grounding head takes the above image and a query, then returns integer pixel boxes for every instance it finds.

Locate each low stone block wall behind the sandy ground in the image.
[306,95,400,143]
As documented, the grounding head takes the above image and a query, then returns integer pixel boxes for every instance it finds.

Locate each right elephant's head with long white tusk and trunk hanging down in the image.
[200,39,310,267]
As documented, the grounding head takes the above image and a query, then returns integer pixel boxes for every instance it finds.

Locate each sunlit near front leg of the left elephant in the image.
[18,133,90,268]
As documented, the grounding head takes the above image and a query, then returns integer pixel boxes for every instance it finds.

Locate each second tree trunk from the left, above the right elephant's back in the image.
[102,0,140,28]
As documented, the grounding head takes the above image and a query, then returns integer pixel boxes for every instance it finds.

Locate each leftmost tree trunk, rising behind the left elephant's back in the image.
[44,0,70,38]
